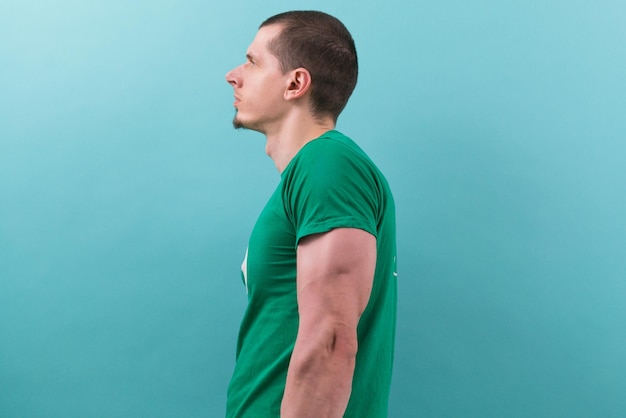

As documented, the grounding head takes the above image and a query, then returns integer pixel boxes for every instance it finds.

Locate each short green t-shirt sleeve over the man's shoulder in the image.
[283,139,379,246]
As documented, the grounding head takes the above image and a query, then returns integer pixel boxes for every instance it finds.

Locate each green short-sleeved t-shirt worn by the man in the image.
[226,131,397,418]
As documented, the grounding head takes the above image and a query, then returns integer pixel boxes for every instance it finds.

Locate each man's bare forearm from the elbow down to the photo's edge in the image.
[281,324,357,418]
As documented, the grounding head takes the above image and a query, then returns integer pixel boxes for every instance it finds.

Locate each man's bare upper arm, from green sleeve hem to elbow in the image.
[297,228,376,332]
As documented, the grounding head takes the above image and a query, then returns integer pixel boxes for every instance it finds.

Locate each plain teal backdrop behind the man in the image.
[0,0,626,418]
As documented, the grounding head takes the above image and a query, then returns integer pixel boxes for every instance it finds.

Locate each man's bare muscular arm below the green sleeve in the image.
[281,228,376,418]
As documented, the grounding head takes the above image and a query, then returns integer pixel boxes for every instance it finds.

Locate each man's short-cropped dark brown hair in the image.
[260,11,359,121]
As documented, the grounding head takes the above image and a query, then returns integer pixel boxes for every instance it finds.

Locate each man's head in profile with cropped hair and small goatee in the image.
[226,11,358,133]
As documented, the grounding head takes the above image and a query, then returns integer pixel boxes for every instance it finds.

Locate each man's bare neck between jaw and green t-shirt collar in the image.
[265,111,335,173]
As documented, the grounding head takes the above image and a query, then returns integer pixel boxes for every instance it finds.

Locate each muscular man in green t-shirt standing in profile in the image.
[226,11,397,418]
